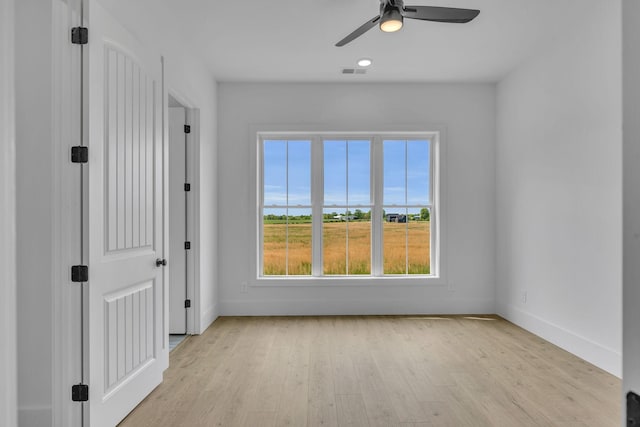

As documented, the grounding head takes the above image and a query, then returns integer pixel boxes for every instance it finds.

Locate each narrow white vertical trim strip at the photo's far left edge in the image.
[0,0,18,427]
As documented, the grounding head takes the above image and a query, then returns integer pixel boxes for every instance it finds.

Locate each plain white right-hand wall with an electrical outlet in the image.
[497,1,622,375]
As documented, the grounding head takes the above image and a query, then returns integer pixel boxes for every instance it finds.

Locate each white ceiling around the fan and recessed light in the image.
[101,0,584,82]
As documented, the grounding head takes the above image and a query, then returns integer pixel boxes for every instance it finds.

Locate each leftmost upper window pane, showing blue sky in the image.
[263,141,287,206]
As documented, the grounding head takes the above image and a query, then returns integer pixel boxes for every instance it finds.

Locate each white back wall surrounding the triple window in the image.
[218,83,495,315]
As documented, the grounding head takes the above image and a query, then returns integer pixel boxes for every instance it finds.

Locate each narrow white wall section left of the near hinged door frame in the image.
[16,0,54,426]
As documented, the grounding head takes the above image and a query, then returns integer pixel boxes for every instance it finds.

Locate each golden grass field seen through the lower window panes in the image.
[263,221,431,276]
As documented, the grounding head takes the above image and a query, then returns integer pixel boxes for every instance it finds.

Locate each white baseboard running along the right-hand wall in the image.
[498,304,622,378]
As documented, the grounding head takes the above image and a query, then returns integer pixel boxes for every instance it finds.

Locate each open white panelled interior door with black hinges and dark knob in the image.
[85,1,168,427]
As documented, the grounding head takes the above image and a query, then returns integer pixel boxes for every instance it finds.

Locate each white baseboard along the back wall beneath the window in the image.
[220,299,495,316]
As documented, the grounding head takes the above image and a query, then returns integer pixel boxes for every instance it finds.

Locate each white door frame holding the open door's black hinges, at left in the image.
[51,0,84,427]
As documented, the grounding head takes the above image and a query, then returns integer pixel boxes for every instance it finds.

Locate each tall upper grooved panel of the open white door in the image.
[104,45,156,251]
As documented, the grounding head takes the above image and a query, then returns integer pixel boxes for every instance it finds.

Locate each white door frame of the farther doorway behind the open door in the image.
[164,91,200,335]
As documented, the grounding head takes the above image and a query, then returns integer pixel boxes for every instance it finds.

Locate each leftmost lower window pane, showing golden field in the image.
[262,209,287,276]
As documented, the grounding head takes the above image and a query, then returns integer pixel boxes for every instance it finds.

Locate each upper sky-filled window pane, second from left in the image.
[288,141,311,206]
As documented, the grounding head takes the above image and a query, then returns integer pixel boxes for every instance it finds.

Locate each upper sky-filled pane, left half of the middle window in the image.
[324,140,347,206]
